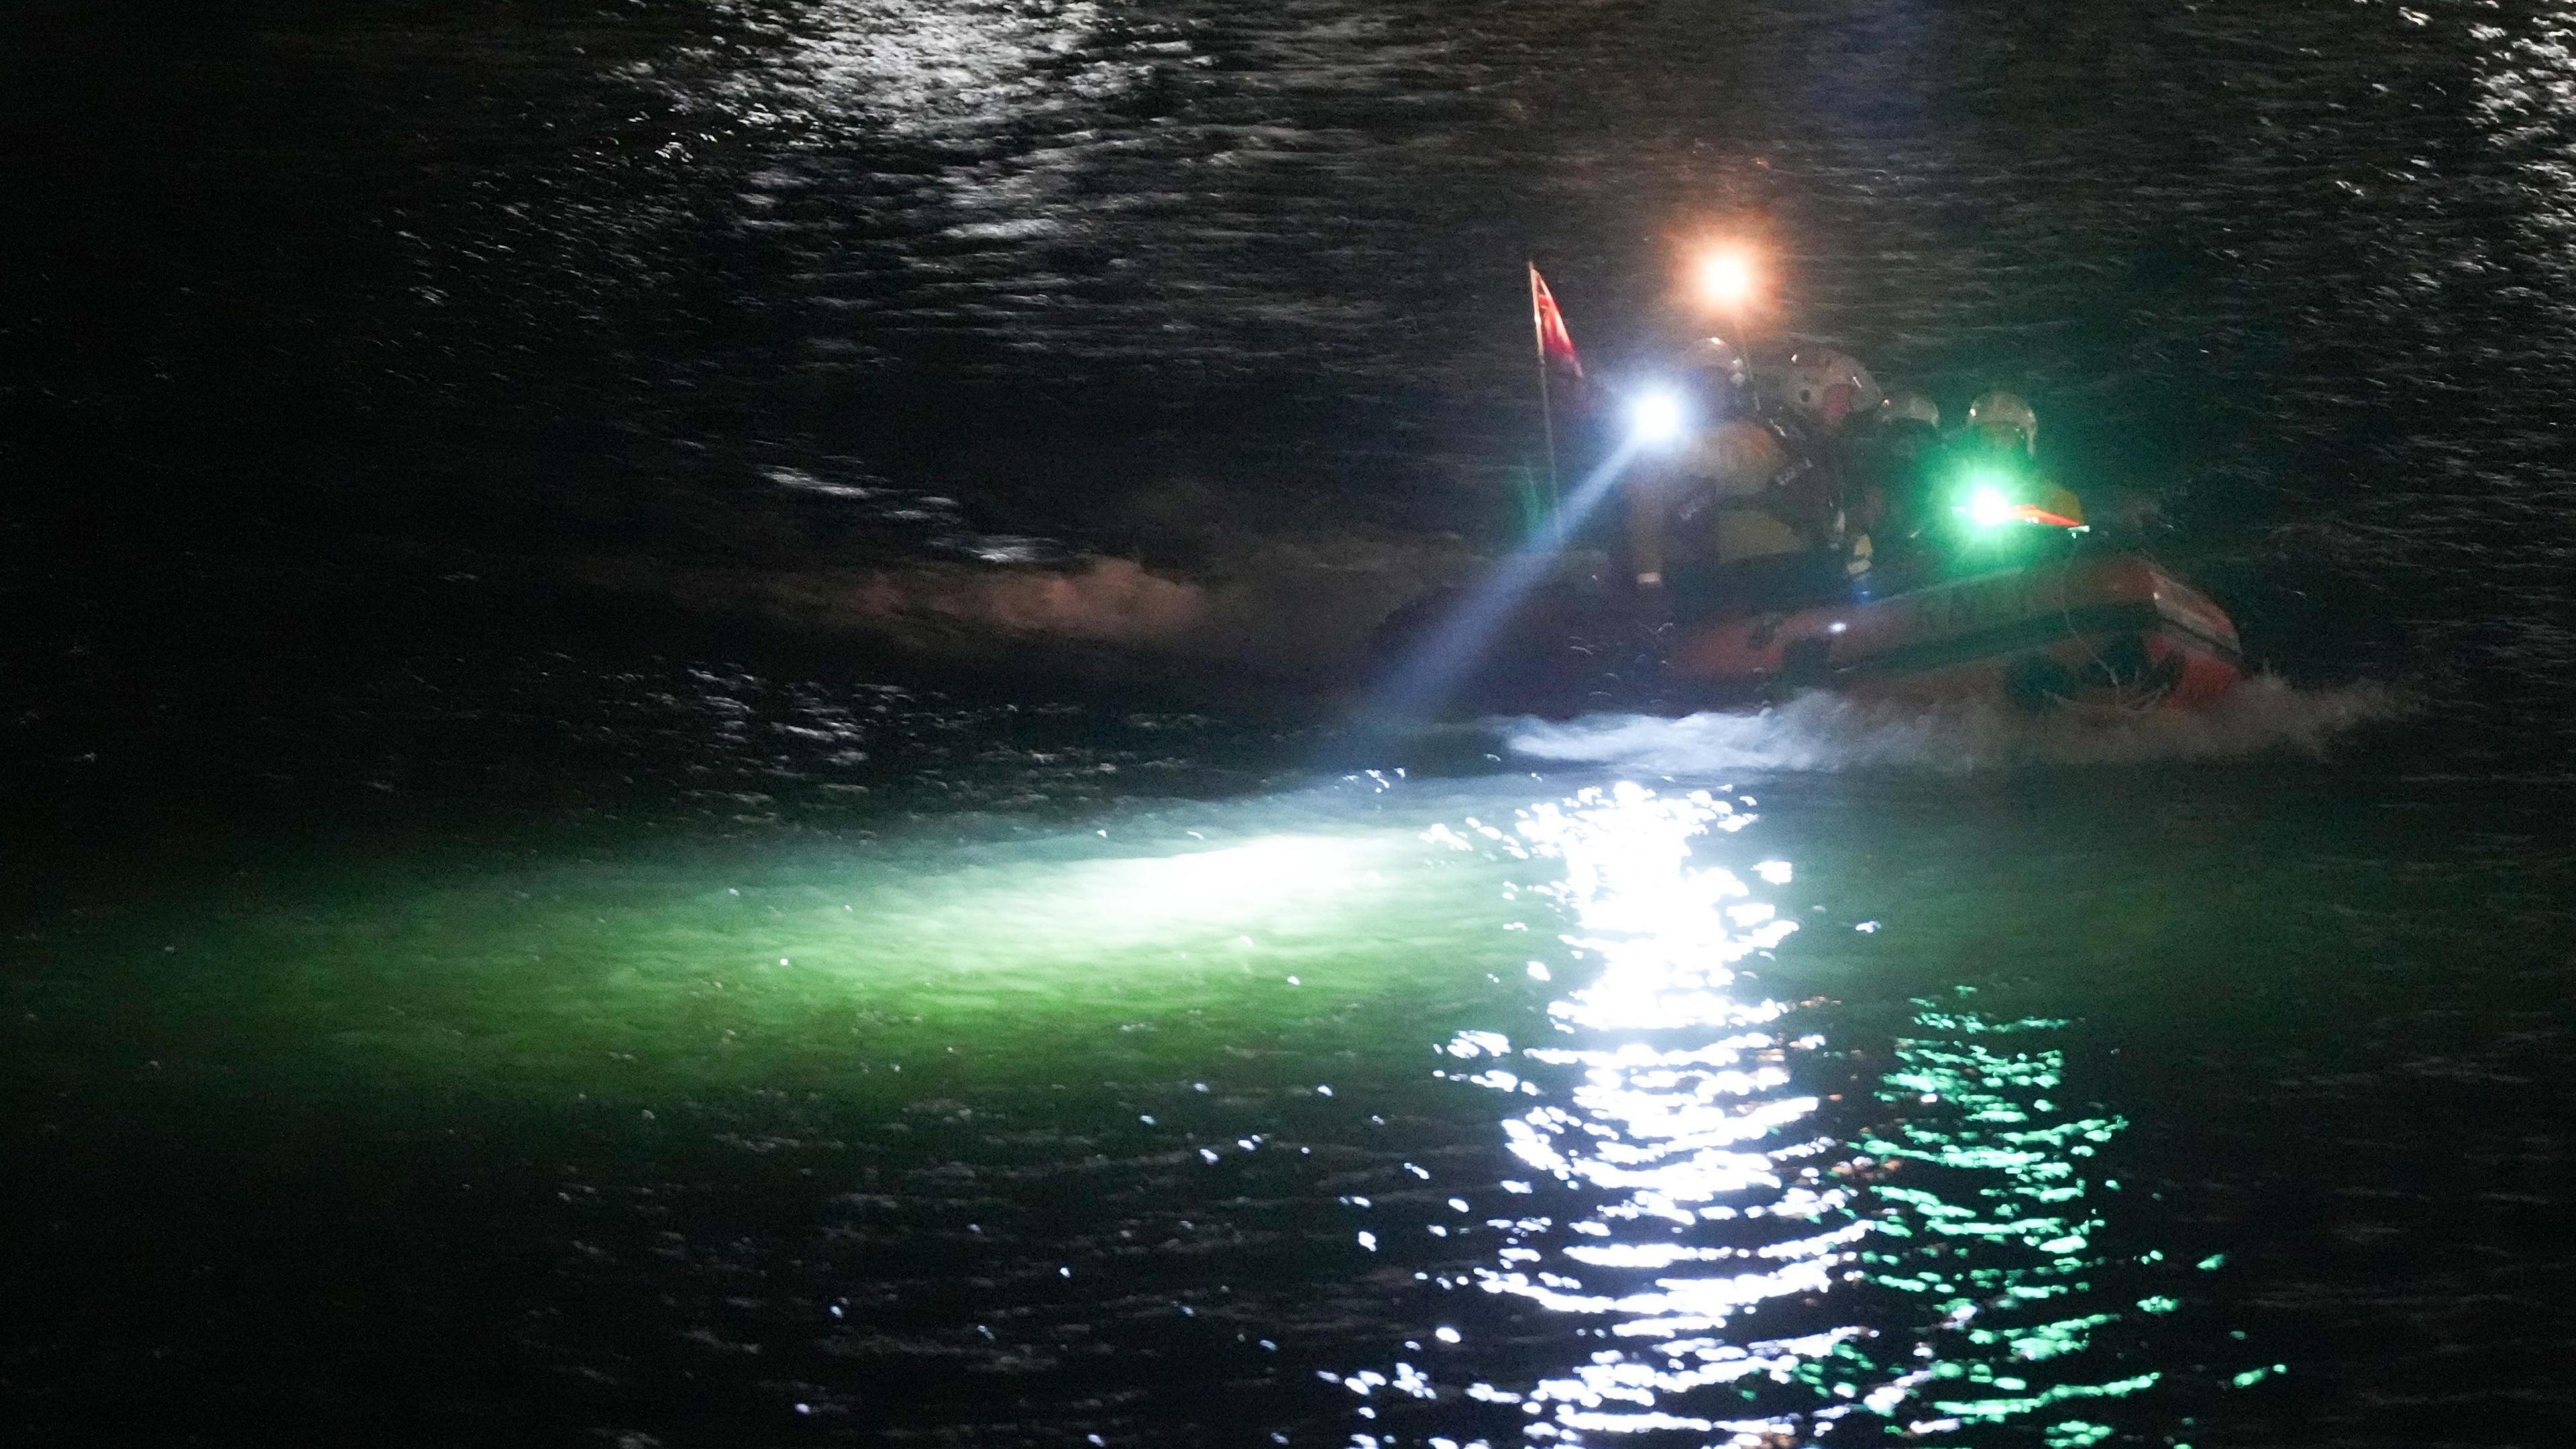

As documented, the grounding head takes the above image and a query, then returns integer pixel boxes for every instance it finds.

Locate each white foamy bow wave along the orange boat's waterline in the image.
[1505,676,2404,773]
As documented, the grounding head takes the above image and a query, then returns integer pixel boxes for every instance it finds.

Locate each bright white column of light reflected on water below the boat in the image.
[1362,784,1870,1444]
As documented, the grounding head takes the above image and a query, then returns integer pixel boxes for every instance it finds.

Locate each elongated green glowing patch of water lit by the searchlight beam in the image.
[15,784,1522,1106]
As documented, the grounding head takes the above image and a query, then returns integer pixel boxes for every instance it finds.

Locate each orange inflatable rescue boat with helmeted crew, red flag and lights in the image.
[1371,245,2246,719]
